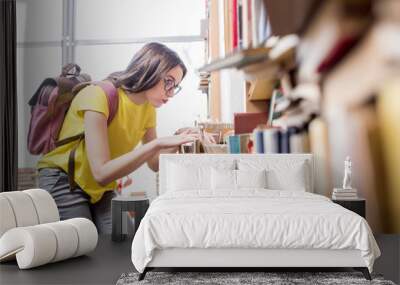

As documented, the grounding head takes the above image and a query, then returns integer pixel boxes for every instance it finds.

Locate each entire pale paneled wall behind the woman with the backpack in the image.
[17,0,207,197]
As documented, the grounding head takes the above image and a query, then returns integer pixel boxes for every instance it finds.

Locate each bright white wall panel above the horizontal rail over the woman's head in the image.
[75,0,205,39]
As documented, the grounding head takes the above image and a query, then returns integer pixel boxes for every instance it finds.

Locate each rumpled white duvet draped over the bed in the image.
[132,189,380,272]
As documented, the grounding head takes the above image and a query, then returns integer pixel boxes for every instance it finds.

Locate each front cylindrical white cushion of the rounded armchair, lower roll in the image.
[0,218,98,269]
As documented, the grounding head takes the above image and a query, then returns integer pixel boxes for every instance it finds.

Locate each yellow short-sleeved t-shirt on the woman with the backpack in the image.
[38,85,156,203]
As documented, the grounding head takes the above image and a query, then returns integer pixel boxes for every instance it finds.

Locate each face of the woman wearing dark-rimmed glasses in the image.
[146,66,183,108]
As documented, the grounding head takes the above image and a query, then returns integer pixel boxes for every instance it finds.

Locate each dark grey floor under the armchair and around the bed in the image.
[0,235,400,285]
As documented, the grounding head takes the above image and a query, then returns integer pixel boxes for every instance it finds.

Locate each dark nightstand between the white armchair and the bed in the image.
[111,196,149,241]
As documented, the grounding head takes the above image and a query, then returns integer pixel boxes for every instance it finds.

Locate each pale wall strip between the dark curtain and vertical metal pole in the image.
[16,0,62,167]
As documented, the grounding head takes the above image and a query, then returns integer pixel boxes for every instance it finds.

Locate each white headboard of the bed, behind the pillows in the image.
[158,153,314,194]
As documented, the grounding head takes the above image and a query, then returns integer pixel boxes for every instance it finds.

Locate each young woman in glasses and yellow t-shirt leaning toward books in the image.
[38,43,198,233]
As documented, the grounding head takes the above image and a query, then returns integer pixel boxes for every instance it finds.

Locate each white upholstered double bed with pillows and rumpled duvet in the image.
[132,154,380,280]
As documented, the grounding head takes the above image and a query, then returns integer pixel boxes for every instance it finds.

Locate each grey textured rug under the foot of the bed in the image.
[117,271,395,285]
